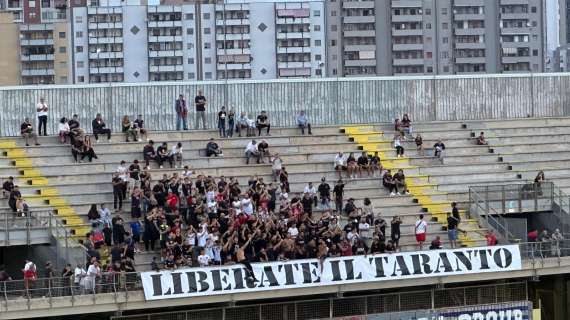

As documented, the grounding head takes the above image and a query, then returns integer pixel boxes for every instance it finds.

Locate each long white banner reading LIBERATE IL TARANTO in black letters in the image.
[141,246,522,300]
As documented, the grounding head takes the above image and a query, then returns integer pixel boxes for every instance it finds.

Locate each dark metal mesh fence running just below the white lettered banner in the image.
[111,282,528,320]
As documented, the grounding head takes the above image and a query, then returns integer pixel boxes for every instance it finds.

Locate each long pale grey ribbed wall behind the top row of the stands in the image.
[0,74,570,136]
